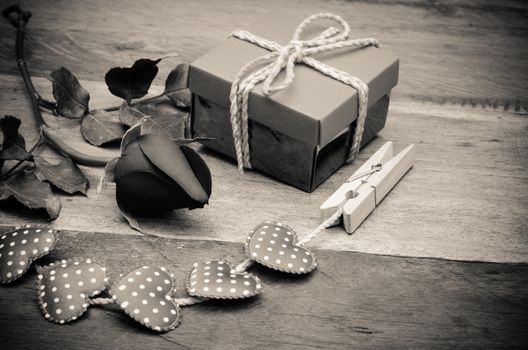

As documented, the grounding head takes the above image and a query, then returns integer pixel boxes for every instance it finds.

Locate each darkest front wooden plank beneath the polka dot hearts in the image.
[0,232,528,349]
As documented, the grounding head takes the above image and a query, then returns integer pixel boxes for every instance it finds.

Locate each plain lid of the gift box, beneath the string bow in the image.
[189,12,399,146]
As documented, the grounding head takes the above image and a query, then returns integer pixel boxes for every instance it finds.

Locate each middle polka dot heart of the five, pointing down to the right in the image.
[110,266,180,332]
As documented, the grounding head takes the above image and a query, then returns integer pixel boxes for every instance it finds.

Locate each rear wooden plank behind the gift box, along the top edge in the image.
[0,0,528,109]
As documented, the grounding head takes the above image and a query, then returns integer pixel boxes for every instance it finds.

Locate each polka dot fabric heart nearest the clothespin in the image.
[246,221,317,274]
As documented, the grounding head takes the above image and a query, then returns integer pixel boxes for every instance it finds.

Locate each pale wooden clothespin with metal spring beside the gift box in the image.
[320,141,415,234]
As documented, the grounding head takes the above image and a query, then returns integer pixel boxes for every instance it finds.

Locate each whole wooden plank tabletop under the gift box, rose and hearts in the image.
[0,0,528,349]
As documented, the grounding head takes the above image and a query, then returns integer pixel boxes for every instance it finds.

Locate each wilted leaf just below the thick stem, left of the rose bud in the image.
[35,150,88,195]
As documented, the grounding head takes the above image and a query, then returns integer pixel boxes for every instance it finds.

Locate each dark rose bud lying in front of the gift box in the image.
[114,134,211,215]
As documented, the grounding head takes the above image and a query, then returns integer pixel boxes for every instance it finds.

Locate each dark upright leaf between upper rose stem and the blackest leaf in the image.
[51,67,90,118]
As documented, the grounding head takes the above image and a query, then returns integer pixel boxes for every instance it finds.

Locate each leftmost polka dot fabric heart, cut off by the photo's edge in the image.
[0,225,57,283]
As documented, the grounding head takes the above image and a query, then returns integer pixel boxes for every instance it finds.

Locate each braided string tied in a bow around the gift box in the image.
[229,13,379,172]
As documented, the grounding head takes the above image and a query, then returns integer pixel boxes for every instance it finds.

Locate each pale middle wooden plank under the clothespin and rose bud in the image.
[0,76,528,262]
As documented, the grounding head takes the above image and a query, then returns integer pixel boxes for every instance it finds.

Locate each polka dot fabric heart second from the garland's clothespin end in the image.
[187,261,262,299]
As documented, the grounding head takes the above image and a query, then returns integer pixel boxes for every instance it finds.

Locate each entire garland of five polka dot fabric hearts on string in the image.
[0,221,317,332]
